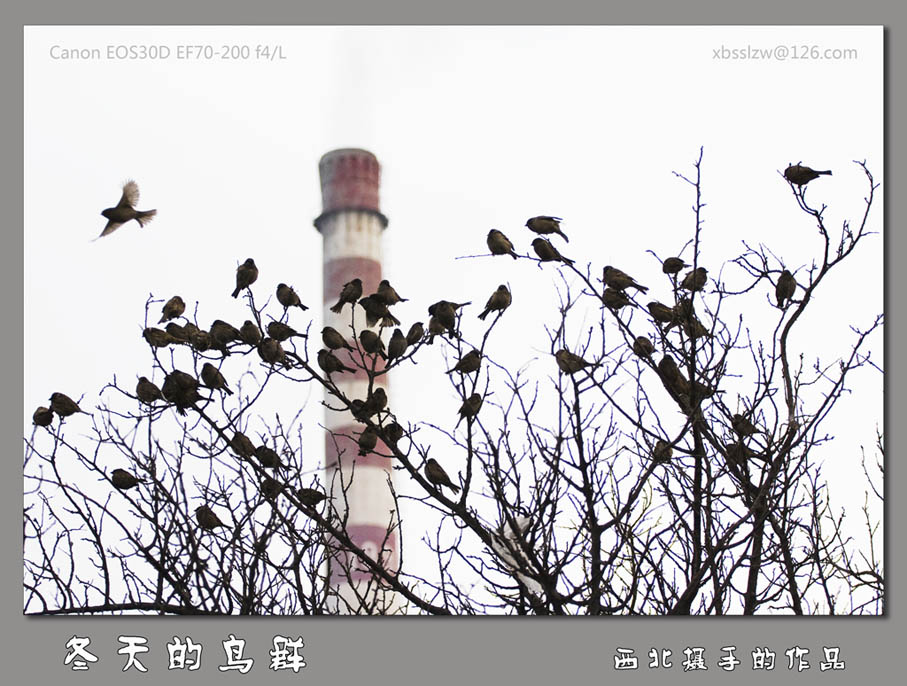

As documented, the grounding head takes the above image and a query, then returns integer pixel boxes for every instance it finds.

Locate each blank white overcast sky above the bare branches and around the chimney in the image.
[23,27,884,608]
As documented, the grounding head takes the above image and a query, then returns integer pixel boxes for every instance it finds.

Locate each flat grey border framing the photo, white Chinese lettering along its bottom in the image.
[0,0,907,685]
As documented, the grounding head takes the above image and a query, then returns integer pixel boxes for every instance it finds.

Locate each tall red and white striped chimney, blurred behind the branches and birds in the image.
[315,148,400,613]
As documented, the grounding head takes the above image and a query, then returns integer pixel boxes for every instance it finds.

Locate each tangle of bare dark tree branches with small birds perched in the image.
[24,152,884,615]
